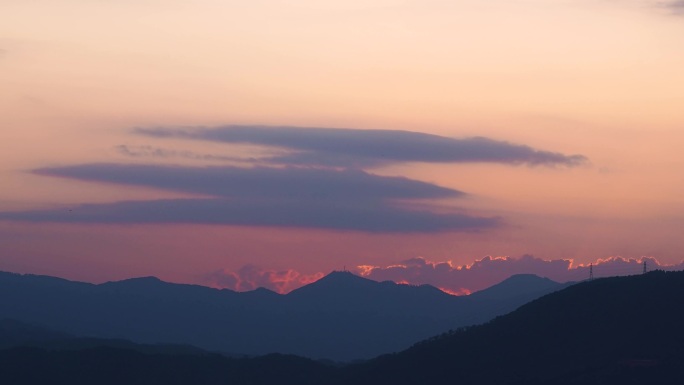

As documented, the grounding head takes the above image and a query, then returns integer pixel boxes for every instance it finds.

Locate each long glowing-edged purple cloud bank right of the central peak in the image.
[356,255,684,293]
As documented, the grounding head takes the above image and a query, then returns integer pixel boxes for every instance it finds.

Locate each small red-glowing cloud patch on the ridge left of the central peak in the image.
[207,265,323,294]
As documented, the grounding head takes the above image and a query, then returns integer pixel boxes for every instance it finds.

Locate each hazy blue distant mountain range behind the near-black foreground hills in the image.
[0,272,562,361]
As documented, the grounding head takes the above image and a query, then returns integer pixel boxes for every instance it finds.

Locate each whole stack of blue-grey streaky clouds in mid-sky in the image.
[6,126,586,233]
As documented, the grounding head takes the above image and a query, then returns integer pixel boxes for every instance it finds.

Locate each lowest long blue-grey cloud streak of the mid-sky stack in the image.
[0,199,500,233]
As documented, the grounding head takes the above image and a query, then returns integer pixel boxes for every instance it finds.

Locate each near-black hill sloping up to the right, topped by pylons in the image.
[345,272,684,385]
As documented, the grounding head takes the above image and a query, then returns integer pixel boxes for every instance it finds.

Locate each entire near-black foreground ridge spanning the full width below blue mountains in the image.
[0,272,684,385]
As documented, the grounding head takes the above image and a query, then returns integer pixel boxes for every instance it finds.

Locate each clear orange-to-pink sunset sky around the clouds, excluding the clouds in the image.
[0,0,684,283]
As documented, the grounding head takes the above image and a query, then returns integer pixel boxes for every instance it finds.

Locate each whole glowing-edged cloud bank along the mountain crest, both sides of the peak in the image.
[207,255,684,295]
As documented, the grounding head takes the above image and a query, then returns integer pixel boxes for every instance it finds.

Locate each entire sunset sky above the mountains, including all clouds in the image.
[0,0,684,294]
